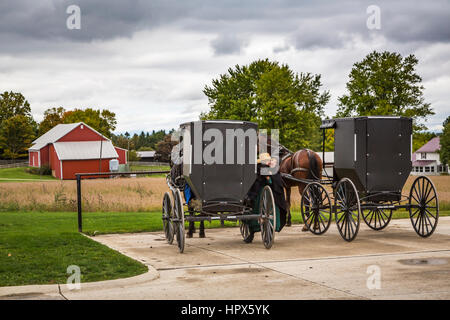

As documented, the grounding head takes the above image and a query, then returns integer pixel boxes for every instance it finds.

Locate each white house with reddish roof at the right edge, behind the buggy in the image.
[411,137,449,175]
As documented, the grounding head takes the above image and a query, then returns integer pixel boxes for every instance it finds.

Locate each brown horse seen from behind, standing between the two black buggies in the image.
[280,149,323,230]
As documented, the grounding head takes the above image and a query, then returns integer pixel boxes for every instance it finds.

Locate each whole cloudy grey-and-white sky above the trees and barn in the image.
[0,0,450,132]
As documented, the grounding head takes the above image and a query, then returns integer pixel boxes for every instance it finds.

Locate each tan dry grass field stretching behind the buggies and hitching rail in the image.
[0,176,450,212]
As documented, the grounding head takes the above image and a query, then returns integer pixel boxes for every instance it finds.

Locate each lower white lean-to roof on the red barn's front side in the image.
[53,140,119,160]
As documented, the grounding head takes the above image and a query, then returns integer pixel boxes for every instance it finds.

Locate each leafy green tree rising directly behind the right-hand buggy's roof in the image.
[337,51,434,132]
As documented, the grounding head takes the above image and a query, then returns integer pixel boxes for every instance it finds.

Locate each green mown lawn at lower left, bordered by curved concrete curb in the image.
[0,212,147,286]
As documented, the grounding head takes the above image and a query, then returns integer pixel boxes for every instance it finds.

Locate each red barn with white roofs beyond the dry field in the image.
[28,122,127,179]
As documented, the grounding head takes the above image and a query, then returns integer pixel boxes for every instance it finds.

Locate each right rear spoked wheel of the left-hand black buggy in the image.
[259,186,277,249]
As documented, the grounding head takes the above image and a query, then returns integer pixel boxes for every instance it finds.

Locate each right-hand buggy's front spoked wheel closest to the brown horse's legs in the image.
[301,182,333,235]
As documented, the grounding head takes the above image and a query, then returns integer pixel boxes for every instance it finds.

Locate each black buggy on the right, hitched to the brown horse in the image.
[283,117,439,241]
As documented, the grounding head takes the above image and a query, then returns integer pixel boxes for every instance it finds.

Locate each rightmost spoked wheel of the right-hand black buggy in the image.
[409,176,439,238]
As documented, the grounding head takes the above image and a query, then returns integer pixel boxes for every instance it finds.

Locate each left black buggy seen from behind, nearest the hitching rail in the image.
[162,120,279,252]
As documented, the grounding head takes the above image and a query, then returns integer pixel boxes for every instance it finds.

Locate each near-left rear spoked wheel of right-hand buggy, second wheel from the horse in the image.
[334,178,361,241]
